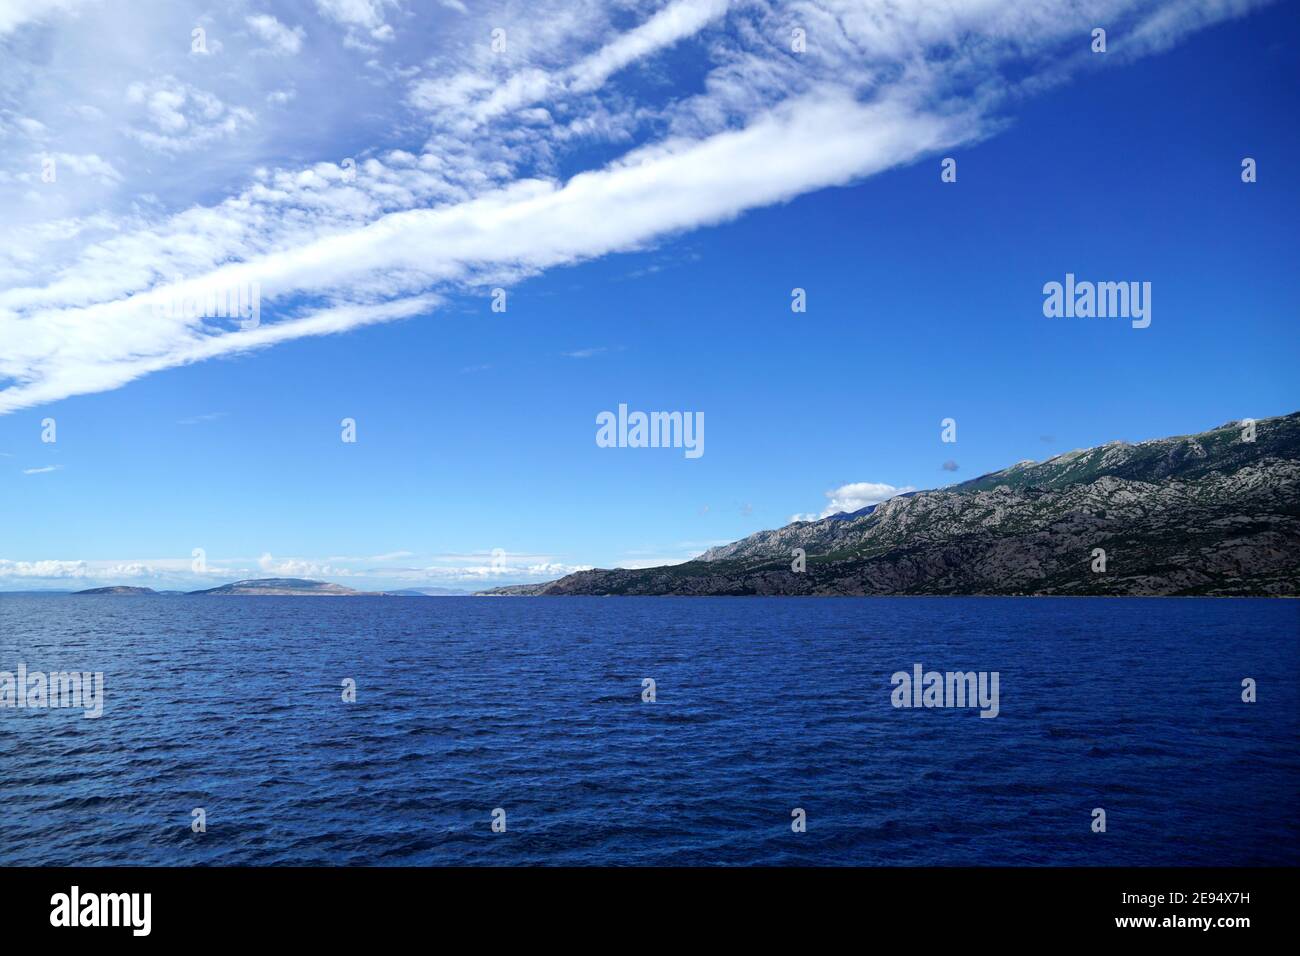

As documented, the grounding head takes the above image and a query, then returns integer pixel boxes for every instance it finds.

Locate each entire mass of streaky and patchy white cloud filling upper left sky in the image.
[0,0,1268,414]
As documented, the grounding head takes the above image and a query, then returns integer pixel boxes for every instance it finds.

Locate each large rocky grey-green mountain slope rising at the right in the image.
[484,412,1300,596]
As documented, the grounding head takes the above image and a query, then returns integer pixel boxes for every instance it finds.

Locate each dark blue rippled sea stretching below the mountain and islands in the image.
[0,596,1300,865]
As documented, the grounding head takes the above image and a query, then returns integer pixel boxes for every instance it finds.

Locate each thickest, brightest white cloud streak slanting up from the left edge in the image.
[0,89,972,412]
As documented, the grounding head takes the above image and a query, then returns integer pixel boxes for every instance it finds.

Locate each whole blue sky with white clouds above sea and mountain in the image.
[0,0,1300,591]
